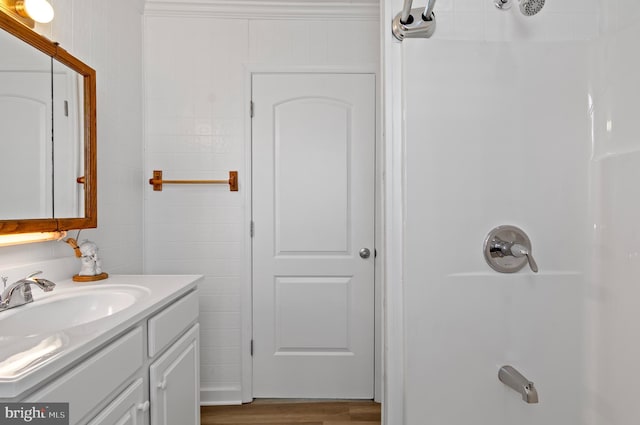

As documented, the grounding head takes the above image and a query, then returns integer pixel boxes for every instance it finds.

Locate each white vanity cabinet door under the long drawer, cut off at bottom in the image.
[88,378,149,425]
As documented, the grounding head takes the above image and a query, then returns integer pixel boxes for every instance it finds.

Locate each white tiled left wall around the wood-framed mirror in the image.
[0,0,143,277]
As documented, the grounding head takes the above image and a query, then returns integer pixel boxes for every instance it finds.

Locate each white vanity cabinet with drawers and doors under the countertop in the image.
[21,282,200,425]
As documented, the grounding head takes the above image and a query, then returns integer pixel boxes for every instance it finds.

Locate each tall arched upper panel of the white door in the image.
[273,97,351,255]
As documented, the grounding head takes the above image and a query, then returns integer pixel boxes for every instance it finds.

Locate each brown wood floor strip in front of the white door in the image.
[200,400,380,425]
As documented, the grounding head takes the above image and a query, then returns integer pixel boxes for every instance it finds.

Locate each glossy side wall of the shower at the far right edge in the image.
[588,0,640,425]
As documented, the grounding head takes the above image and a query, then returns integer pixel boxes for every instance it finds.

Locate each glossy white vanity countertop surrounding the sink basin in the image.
[0,275,202,401]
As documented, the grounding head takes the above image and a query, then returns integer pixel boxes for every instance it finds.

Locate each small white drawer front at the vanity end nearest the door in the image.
[149,291,198,357]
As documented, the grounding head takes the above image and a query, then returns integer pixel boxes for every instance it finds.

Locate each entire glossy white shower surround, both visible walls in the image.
[383,0,640,425]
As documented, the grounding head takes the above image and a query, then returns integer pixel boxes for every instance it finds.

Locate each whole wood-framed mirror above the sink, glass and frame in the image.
[0,10,97,235]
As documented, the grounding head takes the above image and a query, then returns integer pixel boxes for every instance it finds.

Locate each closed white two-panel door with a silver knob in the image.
[252,74,375,398]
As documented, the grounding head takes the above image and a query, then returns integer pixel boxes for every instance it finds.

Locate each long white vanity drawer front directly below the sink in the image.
[25,327,144,425]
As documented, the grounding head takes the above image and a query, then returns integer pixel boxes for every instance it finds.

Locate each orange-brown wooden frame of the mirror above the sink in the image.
[0,10,98,235]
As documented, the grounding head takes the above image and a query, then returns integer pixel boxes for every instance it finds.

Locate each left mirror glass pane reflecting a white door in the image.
[0,26,54,220]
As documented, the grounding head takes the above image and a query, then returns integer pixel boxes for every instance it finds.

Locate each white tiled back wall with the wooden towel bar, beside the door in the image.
[145,1,379,403]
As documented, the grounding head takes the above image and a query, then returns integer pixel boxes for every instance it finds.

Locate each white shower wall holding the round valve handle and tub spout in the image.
[385,0,598,425]
